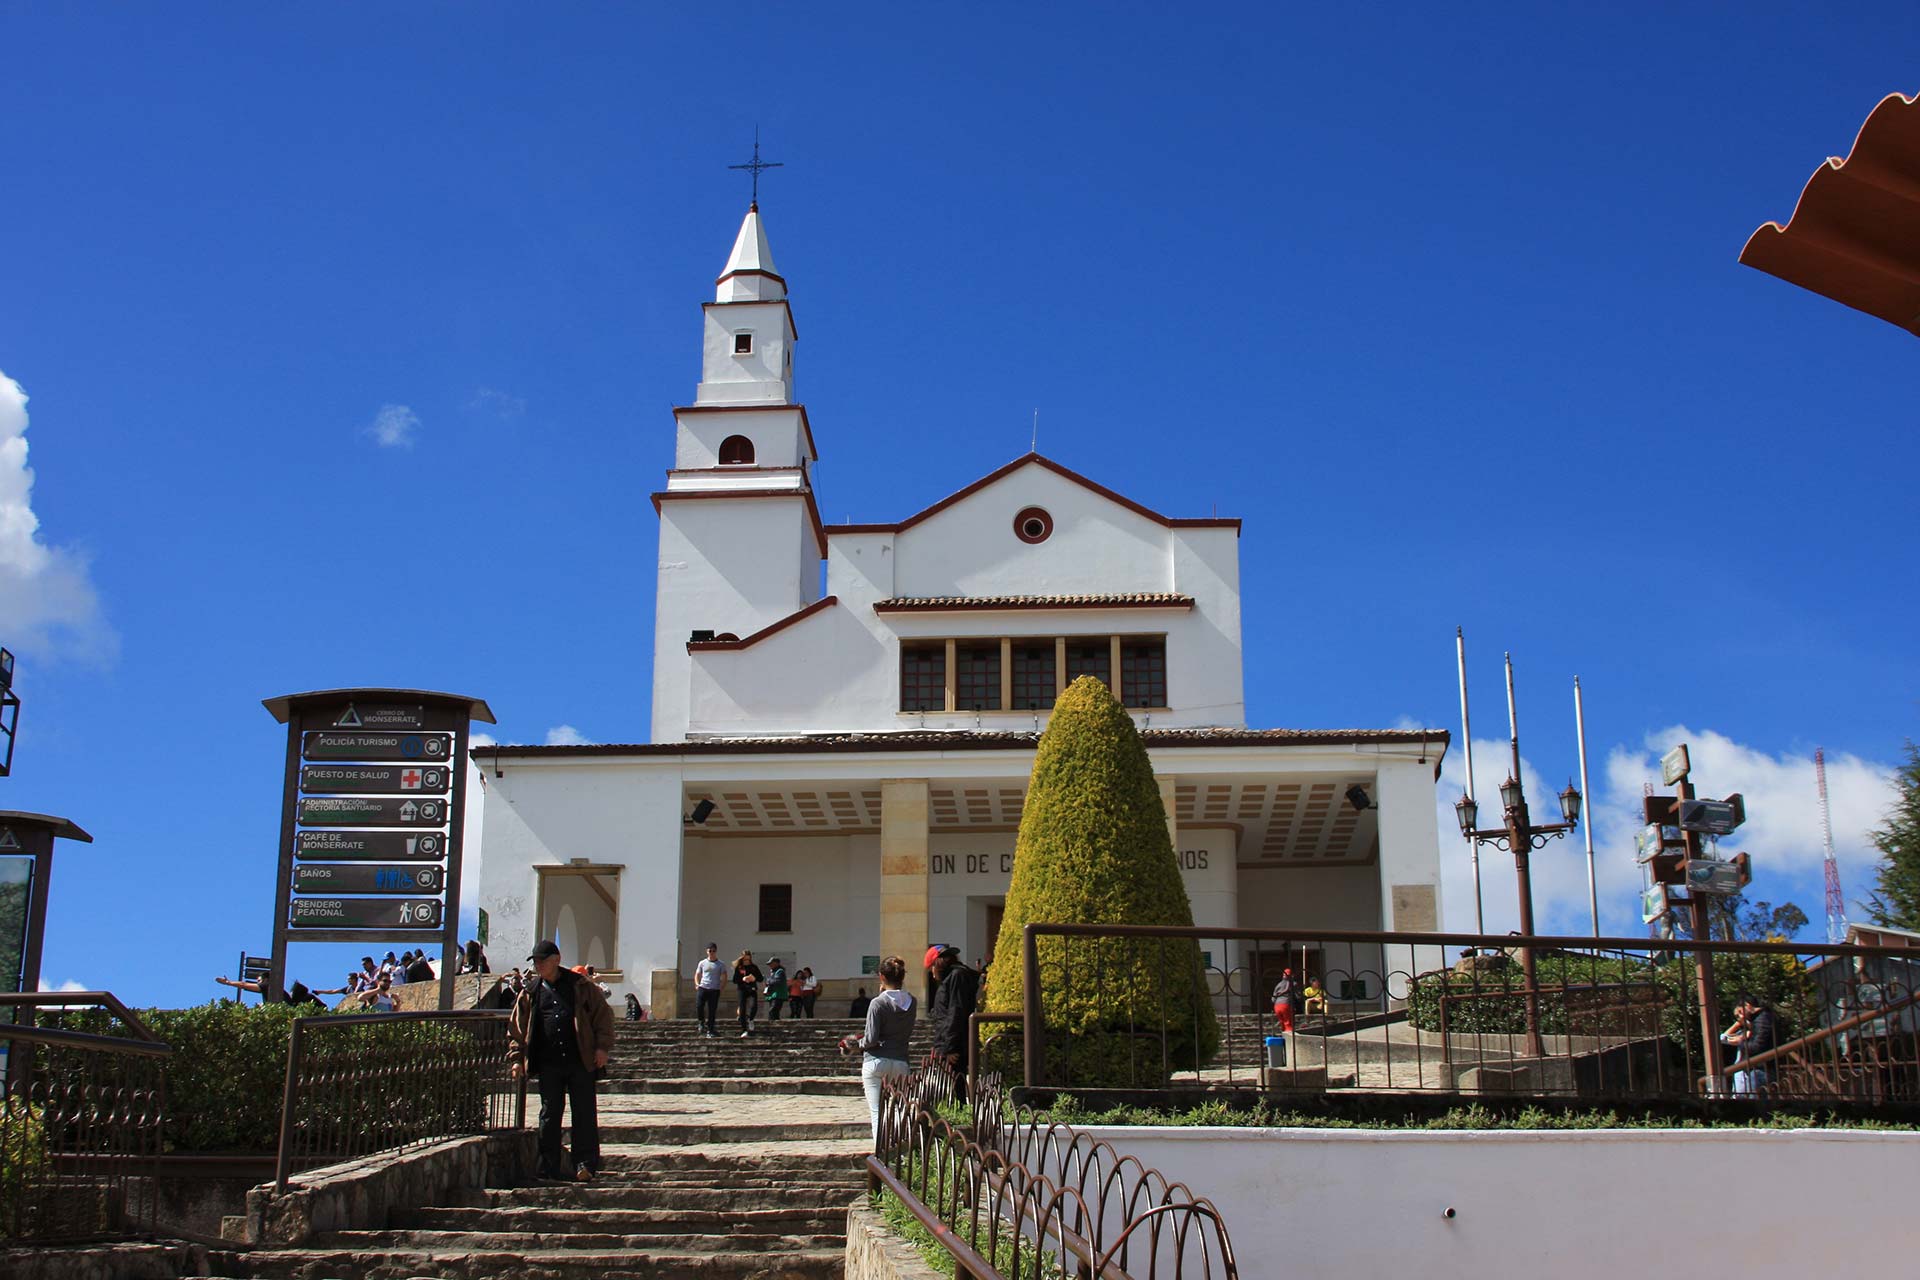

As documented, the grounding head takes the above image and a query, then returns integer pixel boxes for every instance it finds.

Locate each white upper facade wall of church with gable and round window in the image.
[683,464,1246,737]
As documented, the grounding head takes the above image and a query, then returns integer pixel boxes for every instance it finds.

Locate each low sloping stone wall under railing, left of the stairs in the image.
[246,1130,536,1245]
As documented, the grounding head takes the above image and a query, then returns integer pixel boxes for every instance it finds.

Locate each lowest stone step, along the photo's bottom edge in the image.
[207,1245,845,1280]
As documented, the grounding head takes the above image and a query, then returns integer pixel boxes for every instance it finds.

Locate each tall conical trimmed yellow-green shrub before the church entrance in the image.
[983,676,1219,1090]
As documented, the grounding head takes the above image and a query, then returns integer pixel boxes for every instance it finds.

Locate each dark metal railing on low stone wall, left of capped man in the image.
[275,1009,526,1192]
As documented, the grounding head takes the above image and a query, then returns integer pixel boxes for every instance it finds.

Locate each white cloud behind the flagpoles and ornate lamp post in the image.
[1438,725,1893,936]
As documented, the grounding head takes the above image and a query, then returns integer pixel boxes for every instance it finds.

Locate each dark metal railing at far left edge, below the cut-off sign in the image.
[0,992,173,1244]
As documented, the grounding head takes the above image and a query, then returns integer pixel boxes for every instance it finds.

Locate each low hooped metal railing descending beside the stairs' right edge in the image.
[866,1059,1238,1280]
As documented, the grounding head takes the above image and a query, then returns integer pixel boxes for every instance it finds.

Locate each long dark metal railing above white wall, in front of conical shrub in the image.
[1006,925,1920,1105]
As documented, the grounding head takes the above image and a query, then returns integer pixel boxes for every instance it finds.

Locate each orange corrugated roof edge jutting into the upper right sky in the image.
[1740,94,1920,334]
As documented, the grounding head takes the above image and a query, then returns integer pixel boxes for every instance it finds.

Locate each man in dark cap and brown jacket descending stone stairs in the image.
[507,940,612,1182]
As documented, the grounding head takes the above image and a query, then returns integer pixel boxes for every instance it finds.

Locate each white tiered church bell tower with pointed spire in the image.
[653,200,826,743]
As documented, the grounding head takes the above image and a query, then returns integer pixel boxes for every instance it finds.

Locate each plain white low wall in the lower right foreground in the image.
[1085,1126,1920,1280]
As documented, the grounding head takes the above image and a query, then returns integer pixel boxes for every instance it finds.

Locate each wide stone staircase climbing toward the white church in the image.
[189,1019,898,1280]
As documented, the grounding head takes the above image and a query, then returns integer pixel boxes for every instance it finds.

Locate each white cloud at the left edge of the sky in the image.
[0,372,119,662]
